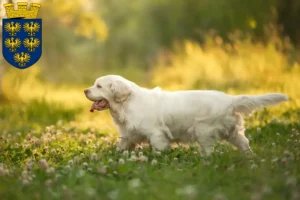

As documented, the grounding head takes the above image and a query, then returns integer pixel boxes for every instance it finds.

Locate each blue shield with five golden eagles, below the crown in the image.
[2,18,42,69]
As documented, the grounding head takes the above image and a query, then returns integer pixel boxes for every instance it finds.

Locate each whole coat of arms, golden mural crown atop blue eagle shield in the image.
[2,2,42,69]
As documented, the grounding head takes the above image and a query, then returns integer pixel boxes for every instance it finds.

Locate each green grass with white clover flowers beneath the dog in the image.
[0,97,300,200]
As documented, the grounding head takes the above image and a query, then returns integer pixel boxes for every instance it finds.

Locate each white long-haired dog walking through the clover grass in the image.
[84,75,288,154]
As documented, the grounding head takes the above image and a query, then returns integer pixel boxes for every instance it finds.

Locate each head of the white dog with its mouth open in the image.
[84,75,132,112]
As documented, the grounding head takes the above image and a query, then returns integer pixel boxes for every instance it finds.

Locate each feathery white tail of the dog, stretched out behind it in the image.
[233,93,289,116]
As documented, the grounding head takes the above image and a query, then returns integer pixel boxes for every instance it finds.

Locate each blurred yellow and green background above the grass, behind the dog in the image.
[0,0,300,133]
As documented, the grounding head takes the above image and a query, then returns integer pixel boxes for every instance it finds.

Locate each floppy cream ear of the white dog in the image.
[110,80,131,103]
